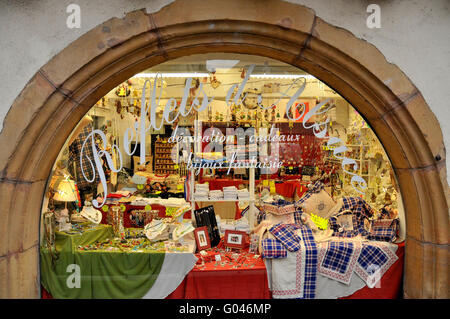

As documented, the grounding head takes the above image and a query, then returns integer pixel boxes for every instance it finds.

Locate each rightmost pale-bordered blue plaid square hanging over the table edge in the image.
[355,242,398,288]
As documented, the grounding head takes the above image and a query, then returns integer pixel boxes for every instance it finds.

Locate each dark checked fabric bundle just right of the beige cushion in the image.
[329,197,375,237]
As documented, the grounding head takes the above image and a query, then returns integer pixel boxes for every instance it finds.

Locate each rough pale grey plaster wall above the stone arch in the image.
[0,0,450,181]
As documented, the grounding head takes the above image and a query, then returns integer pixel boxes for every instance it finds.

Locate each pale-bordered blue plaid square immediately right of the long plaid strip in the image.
[318,241,361,285]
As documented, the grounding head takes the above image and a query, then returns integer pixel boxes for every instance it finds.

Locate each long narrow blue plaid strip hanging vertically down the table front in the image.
[300,226,317,299]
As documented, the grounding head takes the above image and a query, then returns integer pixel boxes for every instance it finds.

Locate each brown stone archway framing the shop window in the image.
[0,0,448,298]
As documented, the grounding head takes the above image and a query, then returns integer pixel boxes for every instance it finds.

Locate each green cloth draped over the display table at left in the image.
[40,225,165,299]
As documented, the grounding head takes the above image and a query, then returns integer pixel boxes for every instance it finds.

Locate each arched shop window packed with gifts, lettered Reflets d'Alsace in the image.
[41,53,405,298]
